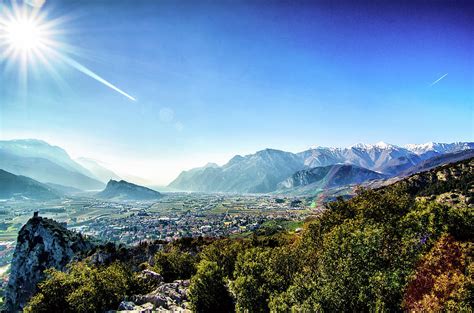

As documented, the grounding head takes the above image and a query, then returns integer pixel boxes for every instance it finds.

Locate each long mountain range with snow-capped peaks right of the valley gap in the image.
[169,142,474,193]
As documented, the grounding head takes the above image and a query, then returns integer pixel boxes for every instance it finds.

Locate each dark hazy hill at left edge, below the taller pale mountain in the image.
[0,169,59,200]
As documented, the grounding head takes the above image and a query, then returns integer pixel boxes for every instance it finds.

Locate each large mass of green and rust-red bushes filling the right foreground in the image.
[191,185,474,312]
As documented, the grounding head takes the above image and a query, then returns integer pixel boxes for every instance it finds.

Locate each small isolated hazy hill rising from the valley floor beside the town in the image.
[97,179,162,200]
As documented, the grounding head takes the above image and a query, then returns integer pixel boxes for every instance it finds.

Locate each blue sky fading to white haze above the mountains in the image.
[0,0,474,184]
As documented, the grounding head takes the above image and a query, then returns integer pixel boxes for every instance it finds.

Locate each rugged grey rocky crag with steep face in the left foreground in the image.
[5,215,94,312]
